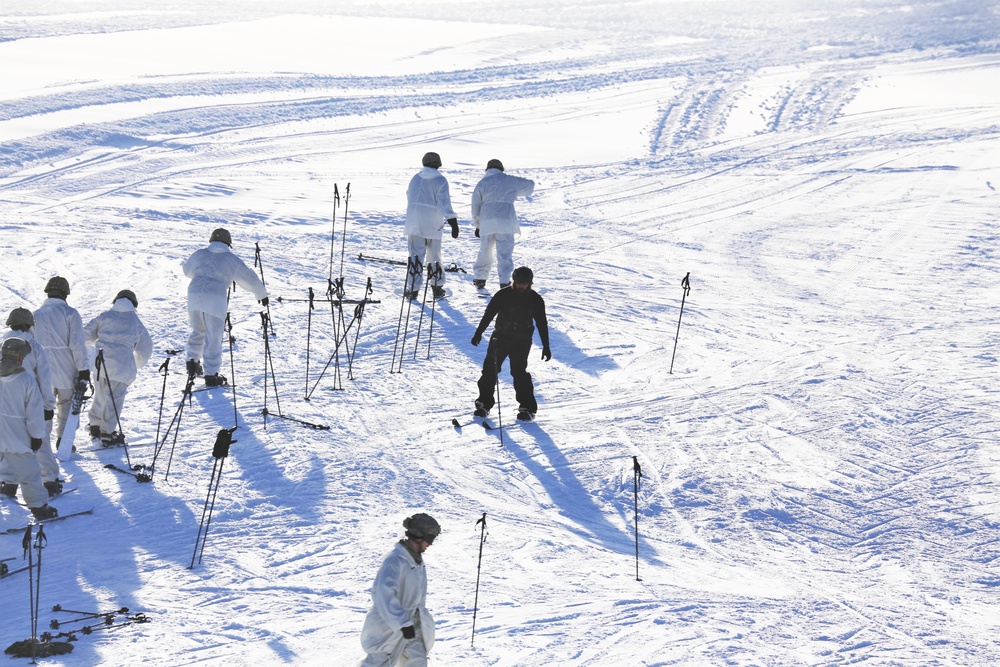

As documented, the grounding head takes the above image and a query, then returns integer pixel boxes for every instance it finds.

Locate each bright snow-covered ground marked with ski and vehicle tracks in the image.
[0,0,1000,667]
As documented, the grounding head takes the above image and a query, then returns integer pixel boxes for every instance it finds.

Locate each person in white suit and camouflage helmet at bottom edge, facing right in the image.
[358,513,441,667]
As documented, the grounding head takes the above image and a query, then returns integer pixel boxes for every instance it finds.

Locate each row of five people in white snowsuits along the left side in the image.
[0,228,267,520]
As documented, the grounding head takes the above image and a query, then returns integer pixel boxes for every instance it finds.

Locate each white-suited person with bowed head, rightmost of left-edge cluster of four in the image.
[83,289,153,445]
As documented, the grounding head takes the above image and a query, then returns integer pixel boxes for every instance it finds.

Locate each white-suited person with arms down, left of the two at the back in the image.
[404,153,458,299]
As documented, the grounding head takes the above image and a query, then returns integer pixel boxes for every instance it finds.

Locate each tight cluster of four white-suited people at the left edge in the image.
[0,276,153,519]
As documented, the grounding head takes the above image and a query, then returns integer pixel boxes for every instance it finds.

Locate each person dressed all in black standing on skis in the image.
[472,266,552,421]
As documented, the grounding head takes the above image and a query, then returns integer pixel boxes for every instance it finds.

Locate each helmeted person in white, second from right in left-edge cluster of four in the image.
[34,276,90,449]
